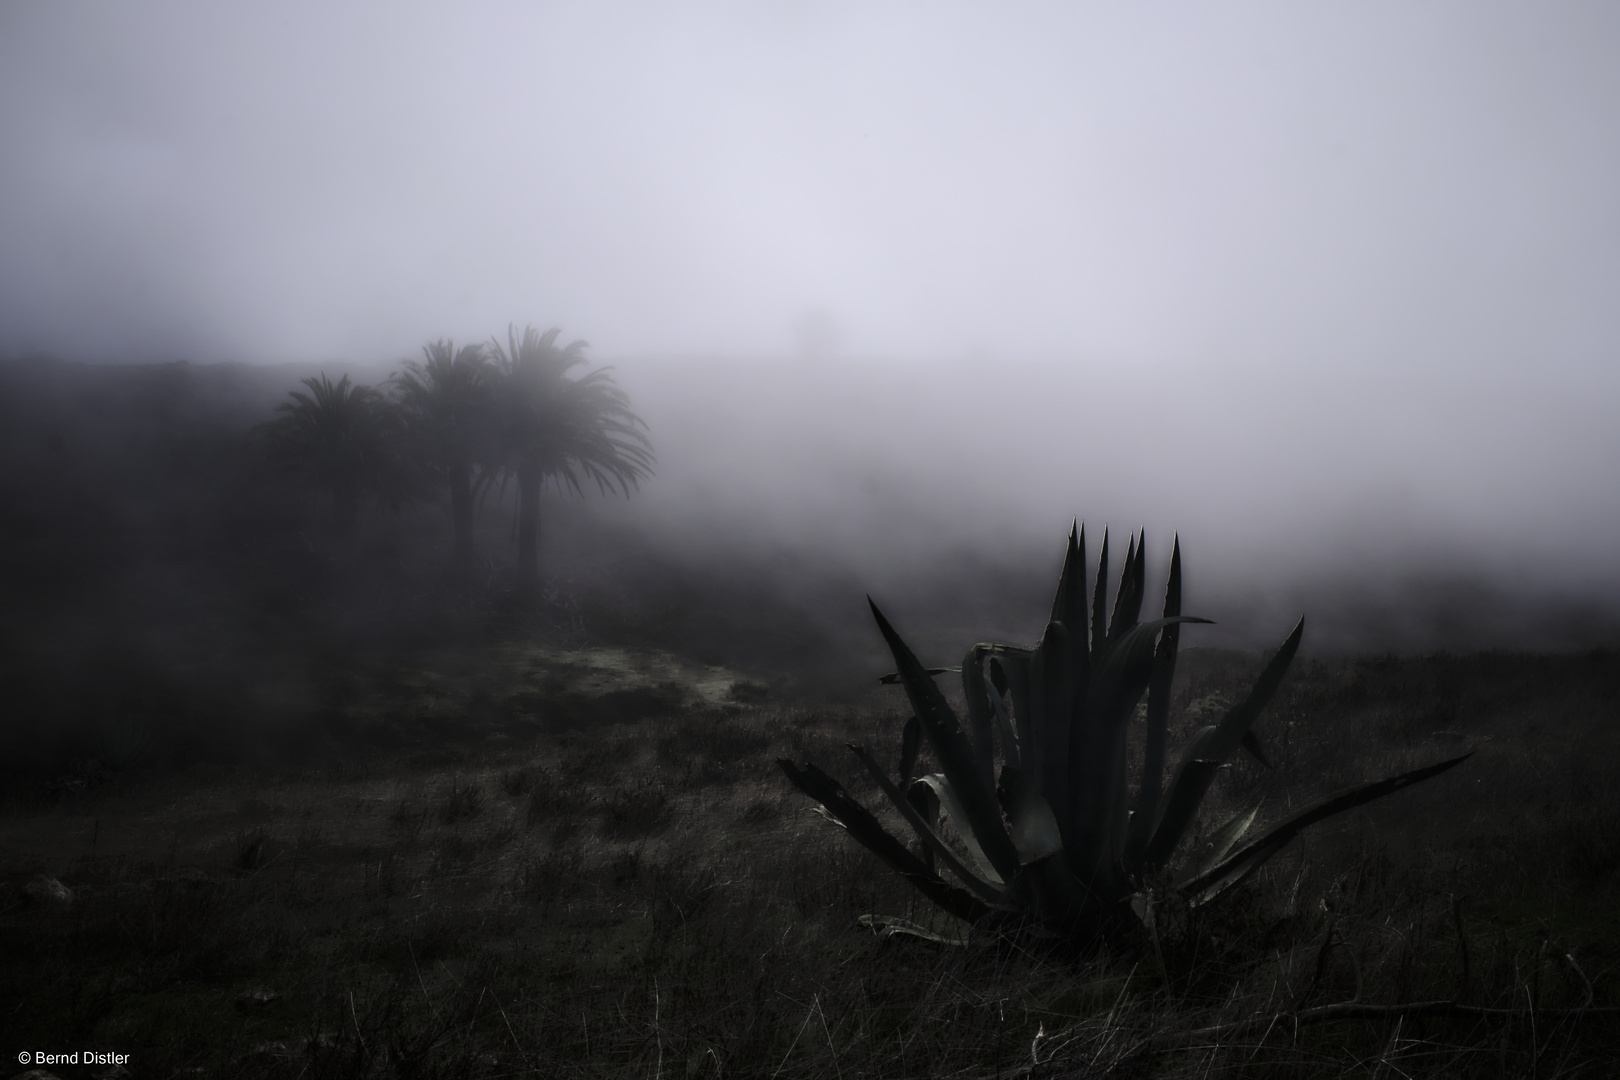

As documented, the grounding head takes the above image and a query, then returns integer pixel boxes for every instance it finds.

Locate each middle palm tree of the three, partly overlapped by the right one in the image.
[394,338,494,572]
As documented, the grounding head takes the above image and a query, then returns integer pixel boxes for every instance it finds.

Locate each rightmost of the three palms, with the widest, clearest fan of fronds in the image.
[489,325,653,596]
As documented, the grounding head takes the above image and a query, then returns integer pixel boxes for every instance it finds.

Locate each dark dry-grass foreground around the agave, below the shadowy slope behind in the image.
[0,638,1620,1080]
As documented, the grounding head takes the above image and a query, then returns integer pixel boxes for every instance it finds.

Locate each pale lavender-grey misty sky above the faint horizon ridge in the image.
[0,2,1620,369]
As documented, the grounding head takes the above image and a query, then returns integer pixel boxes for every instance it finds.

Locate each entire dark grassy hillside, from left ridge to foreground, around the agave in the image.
[0,364,1620,1078]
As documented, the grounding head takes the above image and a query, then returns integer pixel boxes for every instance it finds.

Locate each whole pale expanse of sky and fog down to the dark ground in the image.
[0,3,1620,649]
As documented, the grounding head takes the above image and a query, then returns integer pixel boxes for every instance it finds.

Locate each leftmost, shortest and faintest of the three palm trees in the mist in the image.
[256,372,411,538]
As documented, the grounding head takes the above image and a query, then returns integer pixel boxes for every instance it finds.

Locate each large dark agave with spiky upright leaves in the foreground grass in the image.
[778,528,1468,941]
